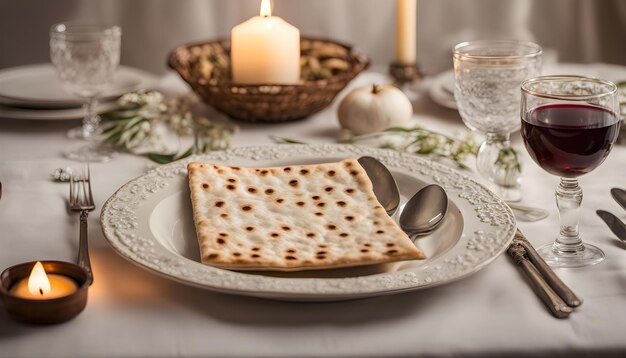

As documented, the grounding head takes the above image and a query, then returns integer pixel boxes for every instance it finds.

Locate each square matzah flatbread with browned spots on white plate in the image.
[188,159,424,271]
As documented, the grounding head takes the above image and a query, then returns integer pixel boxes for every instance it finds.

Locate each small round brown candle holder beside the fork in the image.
[0,261,89,324]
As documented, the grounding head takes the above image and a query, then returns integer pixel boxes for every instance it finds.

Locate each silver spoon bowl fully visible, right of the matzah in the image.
[400,184,448,240]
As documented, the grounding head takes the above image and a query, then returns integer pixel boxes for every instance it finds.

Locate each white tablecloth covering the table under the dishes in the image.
[0,64,626,357]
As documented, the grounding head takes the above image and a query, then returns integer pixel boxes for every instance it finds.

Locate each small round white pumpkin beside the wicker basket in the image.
[337,85,413,134]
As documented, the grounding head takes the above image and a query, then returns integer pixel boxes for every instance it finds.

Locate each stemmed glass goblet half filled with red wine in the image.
[521,76,620,267]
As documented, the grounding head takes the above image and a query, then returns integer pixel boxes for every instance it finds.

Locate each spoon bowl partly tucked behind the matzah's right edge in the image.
[358,156,400,216]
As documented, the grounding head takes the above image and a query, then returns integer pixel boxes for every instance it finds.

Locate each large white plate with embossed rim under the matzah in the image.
[100,145,515,301]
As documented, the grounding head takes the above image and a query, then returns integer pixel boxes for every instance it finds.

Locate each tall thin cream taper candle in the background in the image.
[396,0,417,65]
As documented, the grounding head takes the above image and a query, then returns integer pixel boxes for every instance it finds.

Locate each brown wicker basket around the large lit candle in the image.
[168,38,369,122]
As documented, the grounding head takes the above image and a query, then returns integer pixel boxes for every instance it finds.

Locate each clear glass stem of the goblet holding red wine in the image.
[553,178,585,255]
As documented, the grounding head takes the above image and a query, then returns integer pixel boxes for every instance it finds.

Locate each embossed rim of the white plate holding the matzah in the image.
[100,144,516,300]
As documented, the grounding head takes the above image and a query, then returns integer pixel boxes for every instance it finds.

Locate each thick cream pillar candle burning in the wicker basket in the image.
[230,0,300,84]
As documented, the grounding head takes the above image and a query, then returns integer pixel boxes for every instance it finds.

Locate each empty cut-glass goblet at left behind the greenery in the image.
[50,23,122,161]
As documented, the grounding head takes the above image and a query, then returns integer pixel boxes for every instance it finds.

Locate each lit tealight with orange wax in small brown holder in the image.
[10,261,78,300]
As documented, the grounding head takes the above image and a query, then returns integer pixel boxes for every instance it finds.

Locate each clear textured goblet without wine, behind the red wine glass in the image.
[454,40,542,201]
